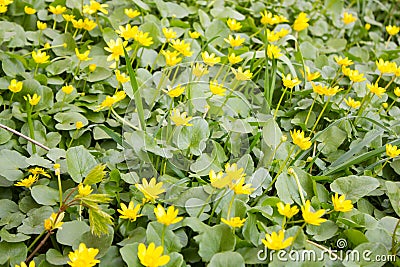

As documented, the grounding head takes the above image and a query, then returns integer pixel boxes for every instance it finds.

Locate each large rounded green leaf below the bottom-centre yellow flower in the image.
[194,224,236,261]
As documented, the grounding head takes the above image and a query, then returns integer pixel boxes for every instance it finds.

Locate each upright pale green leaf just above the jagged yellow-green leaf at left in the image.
[66,146,97,183]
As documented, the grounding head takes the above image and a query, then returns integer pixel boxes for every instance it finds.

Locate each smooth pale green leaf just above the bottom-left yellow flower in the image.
[56,221,90,246]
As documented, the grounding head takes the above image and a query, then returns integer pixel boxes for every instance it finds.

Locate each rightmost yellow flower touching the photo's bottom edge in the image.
[138,242,170,267]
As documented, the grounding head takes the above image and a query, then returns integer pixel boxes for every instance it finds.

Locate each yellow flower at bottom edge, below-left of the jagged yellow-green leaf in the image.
[67,243,100,267]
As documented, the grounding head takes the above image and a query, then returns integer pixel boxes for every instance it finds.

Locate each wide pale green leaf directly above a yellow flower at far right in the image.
[331,175,379,202]
